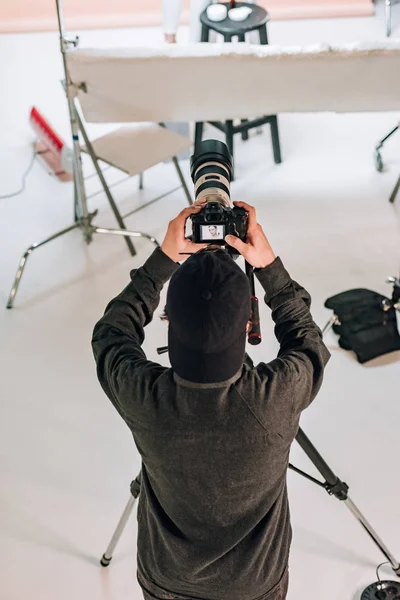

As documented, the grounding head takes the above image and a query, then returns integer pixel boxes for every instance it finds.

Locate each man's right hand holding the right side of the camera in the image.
[225,202,276,269]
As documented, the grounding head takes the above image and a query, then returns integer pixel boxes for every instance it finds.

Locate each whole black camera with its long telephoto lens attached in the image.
[190,140,248,248]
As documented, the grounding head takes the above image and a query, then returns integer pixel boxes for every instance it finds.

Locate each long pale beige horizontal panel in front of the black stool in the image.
[67,40,400,123]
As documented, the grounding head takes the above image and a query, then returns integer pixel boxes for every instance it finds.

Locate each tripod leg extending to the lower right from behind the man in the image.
[290,429,400,577]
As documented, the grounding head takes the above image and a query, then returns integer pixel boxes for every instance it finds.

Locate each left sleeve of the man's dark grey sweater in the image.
[92,248,179,424]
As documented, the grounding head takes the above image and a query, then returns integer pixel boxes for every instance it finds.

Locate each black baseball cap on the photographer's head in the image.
[166,249,251,383]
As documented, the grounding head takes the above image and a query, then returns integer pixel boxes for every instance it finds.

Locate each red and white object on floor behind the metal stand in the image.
[29,107,74,181]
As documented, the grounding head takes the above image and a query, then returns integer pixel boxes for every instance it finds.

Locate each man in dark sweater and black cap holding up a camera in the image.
[93,202,329,600]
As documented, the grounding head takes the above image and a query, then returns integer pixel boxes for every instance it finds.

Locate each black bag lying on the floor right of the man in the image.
[324,277,400,363]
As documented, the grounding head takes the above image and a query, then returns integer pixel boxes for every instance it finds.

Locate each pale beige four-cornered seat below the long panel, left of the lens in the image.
[82,123,192,176]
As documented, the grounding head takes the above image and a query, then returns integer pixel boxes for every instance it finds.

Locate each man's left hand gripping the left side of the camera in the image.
[161,200,207,262]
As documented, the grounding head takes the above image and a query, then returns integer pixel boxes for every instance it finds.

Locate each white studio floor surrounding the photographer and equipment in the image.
[0,5,400,600]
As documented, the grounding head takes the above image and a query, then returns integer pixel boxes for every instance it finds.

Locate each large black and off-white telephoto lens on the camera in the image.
[190,140,232,207]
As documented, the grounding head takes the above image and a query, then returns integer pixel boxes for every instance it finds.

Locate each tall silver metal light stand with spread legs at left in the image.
[7,0,159,308]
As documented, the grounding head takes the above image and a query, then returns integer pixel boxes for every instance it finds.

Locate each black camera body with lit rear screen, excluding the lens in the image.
[192,201,248,246]
